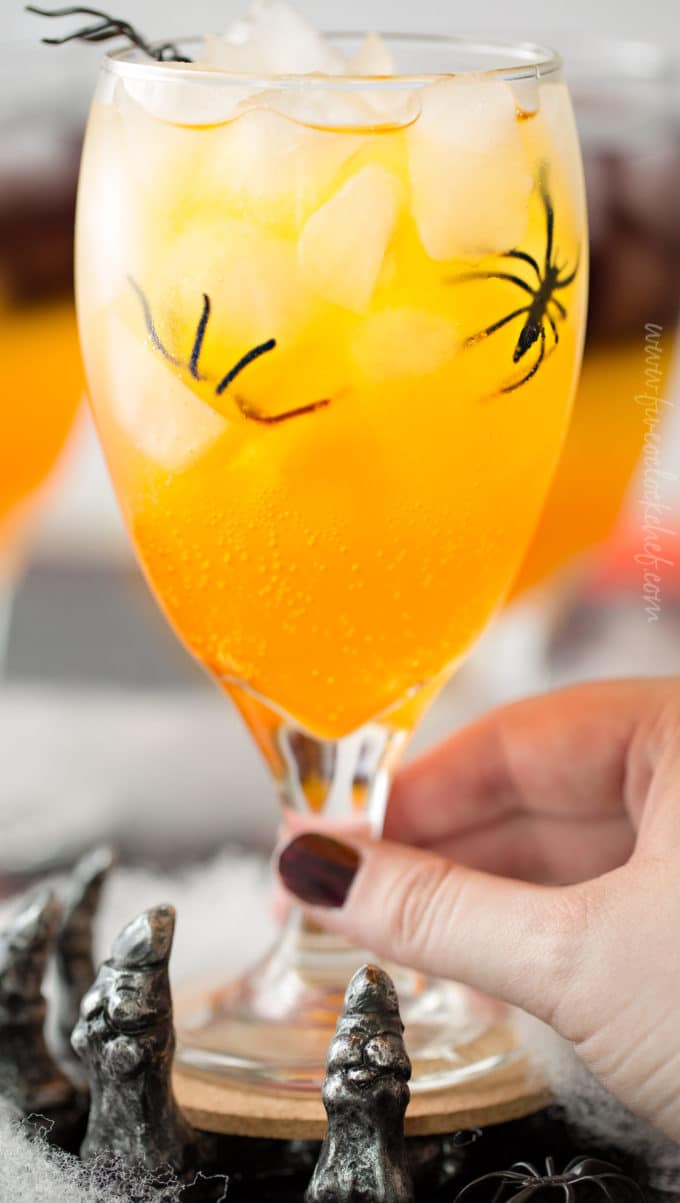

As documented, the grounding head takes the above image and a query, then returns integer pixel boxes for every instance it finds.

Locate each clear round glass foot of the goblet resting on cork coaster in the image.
[178,915,521,1091]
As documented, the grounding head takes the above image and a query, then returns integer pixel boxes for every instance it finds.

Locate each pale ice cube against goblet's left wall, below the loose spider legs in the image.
[107,315,227,472]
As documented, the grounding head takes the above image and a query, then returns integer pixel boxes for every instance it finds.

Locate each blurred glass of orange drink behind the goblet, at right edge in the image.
[515,37,680,593]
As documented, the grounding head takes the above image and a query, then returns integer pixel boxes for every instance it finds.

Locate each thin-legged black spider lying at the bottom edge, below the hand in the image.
[455,1157,645,1203]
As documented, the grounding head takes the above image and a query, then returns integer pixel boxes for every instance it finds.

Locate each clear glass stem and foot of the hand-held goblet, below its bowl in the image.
[179,686,508,1090]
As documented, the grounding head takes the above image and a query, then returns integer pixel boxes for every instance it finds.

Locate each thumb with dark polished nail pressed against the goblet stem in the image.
[278,832,587,1023]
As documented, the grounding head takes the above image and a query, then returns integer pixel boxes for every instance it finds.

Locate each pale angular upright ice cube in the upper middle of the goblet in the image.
[298,165,400,313]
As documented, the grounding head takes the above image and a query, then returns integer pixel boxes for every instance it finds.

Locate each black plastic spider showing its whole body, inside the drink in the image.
[450,170,579,392]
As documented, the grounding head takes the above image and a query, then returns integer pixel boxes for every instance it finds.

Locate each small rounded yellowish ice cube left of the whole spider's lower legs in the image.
[353,306,460,384]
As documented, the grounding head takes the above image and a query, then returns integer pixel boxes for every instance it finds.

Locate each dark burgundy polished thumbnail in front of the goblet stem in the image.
[278,831,361,908]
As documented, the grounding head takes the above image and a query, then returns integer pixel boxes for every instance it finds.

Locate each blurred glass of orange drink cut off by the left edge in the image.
[0,43,84,669]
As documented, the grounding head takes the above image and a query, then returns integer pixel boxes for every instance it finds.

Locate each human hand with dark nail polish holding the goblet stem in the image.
[279,678,680,1140]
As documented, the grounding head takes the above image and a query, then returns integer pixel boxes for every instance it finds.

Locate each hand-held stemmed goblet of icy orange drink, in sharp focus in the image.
[72,35,587,1089]
